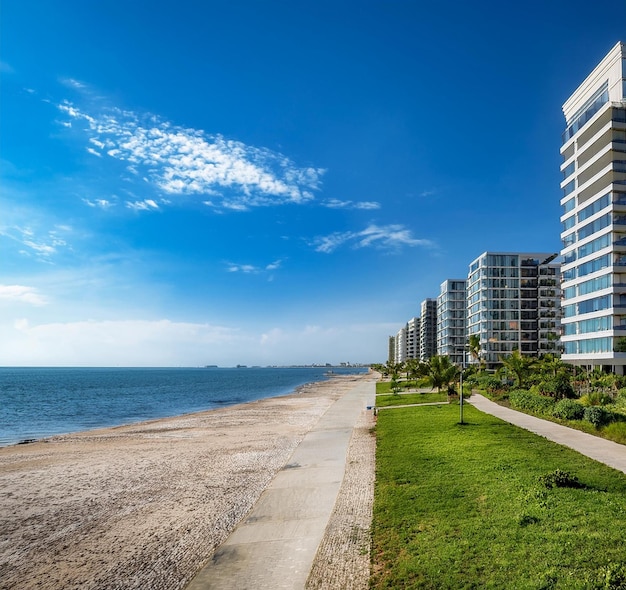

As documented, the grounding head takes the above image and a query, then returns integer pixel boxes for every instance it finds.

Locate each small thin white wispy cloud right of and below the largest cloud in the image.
[311,224,434,253]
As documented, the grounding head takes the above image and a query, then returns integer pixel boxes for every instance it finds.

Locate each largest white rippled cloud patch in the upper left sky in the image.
[58,102,323,210]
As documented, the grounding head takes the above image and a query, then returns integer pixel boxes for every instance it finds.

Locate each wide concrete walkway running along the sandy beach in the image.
[187,380,376,590]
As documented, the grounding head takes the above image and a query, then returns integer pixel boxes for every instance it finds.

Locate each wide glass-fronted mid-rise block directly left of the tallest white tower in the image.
[467,252,561,369]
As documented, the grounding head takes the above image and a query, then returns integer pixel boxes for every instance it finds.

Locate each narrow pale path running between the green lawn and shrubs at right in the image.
[466,393,626,473]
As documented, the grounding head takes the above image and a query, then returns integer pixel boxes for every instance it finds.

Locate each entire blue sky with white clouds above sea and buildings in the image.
[0,0,626,366]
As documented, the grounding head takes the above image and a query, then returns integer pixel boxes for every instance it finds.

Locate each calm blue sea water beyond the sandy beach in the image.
[0,367,366,446]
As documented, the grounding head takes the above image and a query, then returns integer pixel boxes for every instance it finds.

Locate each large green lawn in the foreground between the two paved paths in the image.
[371,405,626,590]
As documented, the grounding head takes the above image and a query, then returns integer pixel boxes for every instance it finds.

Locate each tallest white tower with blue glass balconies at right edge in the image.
[561,43,626,374]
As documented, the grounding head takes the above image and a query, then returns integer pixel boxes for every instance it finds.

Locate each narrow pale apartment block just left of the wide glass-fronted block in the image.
[437,279,467,366]
